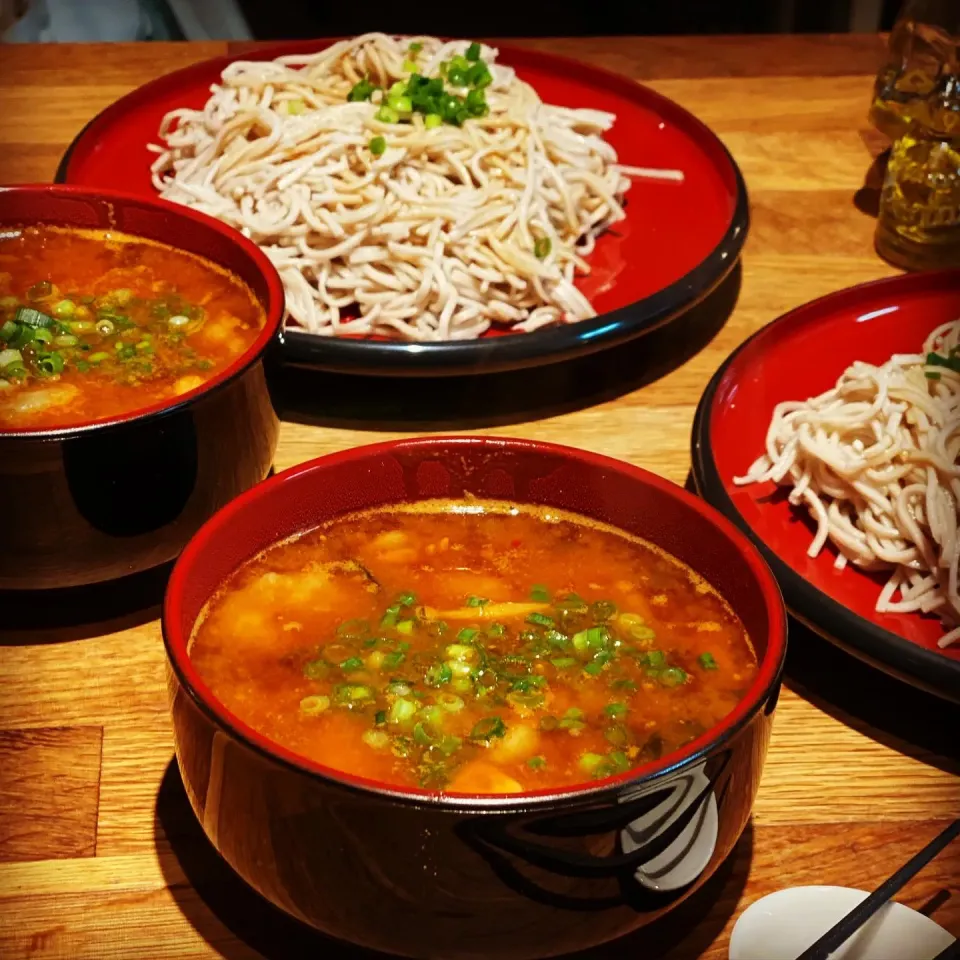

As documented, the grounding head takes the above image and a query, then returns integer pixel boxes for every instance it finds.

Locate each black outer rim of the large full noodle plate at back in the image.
[54,57,750,377]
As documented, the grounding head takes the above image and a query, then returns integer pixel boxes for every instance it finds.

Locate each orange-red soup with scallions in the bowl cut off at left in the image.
[0,226,265,430]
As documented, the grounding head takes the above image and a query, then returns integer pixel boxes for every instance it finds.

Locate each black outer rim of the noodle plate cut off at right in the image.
[690,296,960,703]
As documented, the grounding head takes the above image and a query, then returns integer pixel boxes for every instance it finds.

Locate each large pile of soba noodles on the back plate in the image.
[151,33,682,340]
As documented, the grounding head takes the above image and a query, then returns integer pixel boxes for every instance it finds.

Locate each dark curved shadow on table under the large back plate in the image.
[270,263,741,431]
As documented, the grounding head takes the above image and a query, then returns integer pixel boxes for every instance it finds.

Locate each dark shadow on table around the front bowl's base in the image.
[154,759,753,960]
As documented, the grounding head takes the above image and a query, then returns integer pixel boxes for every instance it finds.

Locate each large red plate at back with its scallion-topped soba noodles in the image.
[59,33,747,373]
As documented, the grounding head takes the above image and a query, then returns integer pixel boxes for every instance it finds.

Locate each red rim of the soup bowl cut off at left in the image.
[0,183,285,442]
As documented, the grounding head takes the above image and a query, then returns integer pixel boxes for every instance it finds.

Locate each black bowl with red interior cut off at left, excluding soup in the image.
[0,185,283,591]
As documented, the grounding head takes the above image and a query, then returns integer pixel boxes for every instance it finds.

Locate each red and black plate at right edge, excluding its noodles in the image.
[692,270,960,702]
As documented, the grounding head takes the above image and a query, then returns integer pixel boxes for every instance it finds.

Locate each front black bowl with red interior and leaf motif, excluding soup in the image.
[163,437,786,960]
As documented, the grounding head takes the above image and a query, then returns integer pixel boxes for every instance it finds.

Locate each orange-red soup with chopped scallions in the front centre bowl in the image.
[190,501,757,793]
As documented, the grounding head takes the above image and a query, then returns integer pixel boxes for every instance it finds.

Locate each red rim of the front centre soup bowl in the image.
[161,434,787,812]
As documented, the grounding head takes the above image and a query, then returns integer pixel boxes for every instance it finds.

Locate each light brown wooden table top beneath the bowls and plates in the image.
[0,37,960,960]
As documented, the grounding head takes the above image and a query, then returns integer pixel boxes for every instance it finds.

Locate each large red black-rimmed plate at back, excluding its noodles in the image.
[57,40,748,376]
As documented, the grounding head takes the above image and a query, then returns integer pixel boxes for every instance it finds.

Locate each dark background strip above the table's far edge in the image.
[239,0,908,40]
